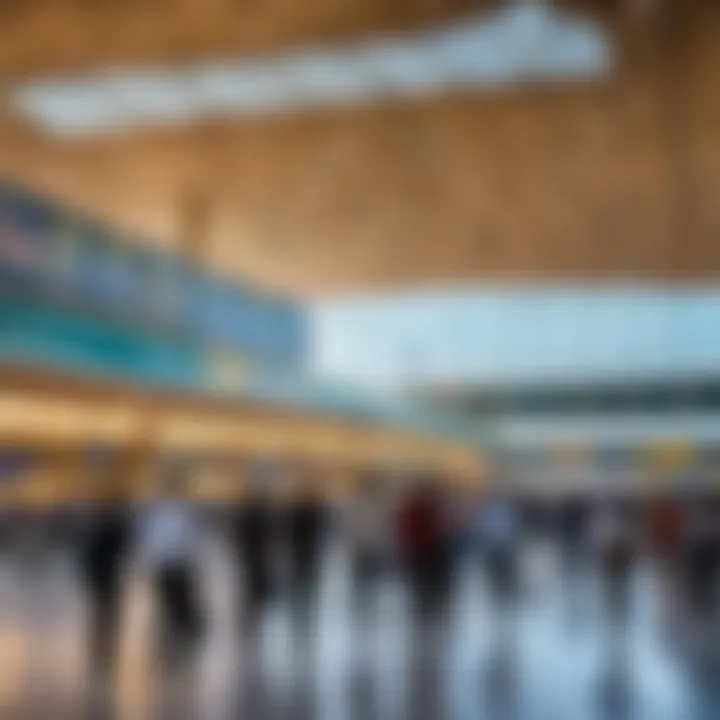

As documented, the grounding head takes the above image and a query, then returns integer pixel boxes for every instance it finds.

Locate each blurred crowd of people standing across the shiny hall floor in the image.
[32,467,720,688]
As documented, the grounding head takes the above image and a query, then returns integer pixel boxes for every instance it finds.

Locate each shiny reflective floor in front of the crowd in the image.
[0,538,720,720]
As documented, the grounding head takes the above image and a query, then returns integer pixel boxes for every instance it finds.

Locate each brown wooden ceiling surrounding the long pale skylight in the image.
[0,0,720,294]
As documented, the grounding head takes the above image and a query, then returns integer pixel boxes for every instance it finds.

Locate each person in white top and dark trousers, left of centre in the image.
[140,467,204,642]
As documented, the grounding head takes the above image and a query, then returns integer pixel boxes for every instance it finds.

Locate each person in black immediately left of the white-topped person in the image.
[80,498,131,672]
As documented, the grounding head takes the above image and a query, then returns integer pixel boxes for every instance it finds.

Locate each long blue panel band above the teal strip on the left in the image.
[0,180,306,368]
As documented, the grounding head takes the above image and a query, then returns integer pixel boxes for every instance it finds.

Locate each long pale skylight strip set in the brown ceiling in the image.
[10,0,612,135]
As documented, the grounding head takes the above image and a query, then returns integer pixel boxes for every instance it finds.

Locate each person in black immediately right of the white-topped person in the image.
[234,467,276,612]
